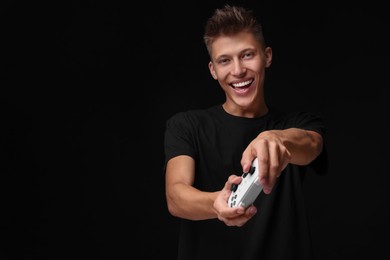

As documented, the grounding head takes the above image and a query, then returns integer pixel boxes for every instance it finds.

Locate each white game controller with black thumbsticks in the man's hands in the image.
[228,158,263,208]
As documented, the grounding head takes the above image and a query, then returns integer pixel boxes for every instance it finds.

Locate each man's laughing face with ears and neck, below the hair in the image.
[209,32,272,117]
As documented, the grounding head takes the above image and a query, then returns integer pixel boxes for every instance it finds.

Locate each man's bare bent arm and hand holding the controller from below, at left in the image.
[166,155,256,223]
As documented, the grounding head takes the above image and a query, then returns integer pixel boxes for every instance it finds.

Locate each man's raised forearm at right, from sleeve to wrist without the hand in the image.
[258,128,323,165]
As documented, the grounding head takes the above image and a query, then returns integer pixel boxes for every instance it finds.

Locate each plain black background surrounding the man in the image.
[0,1,390,260]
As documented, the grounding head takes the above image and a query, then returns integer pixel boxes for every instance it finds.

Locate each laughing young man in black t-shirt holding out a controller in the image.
[164,5,325,260]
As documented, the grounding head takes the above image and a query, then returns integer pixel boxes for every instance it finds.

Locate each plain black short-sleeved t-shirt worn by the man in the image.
[165,105,325,260]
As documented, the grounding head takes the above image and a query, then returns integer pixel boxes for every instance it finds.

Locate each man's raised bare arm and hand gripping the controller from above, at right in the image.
[241,128,323,194]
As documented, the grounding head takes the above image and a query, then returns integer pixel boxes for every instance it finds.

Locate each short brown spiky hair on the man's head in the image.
[203,4,266,55]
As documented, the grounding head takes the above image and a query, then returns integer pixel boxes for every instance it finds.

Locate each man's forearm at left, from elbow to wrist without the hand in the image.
[167,183,218,220]
